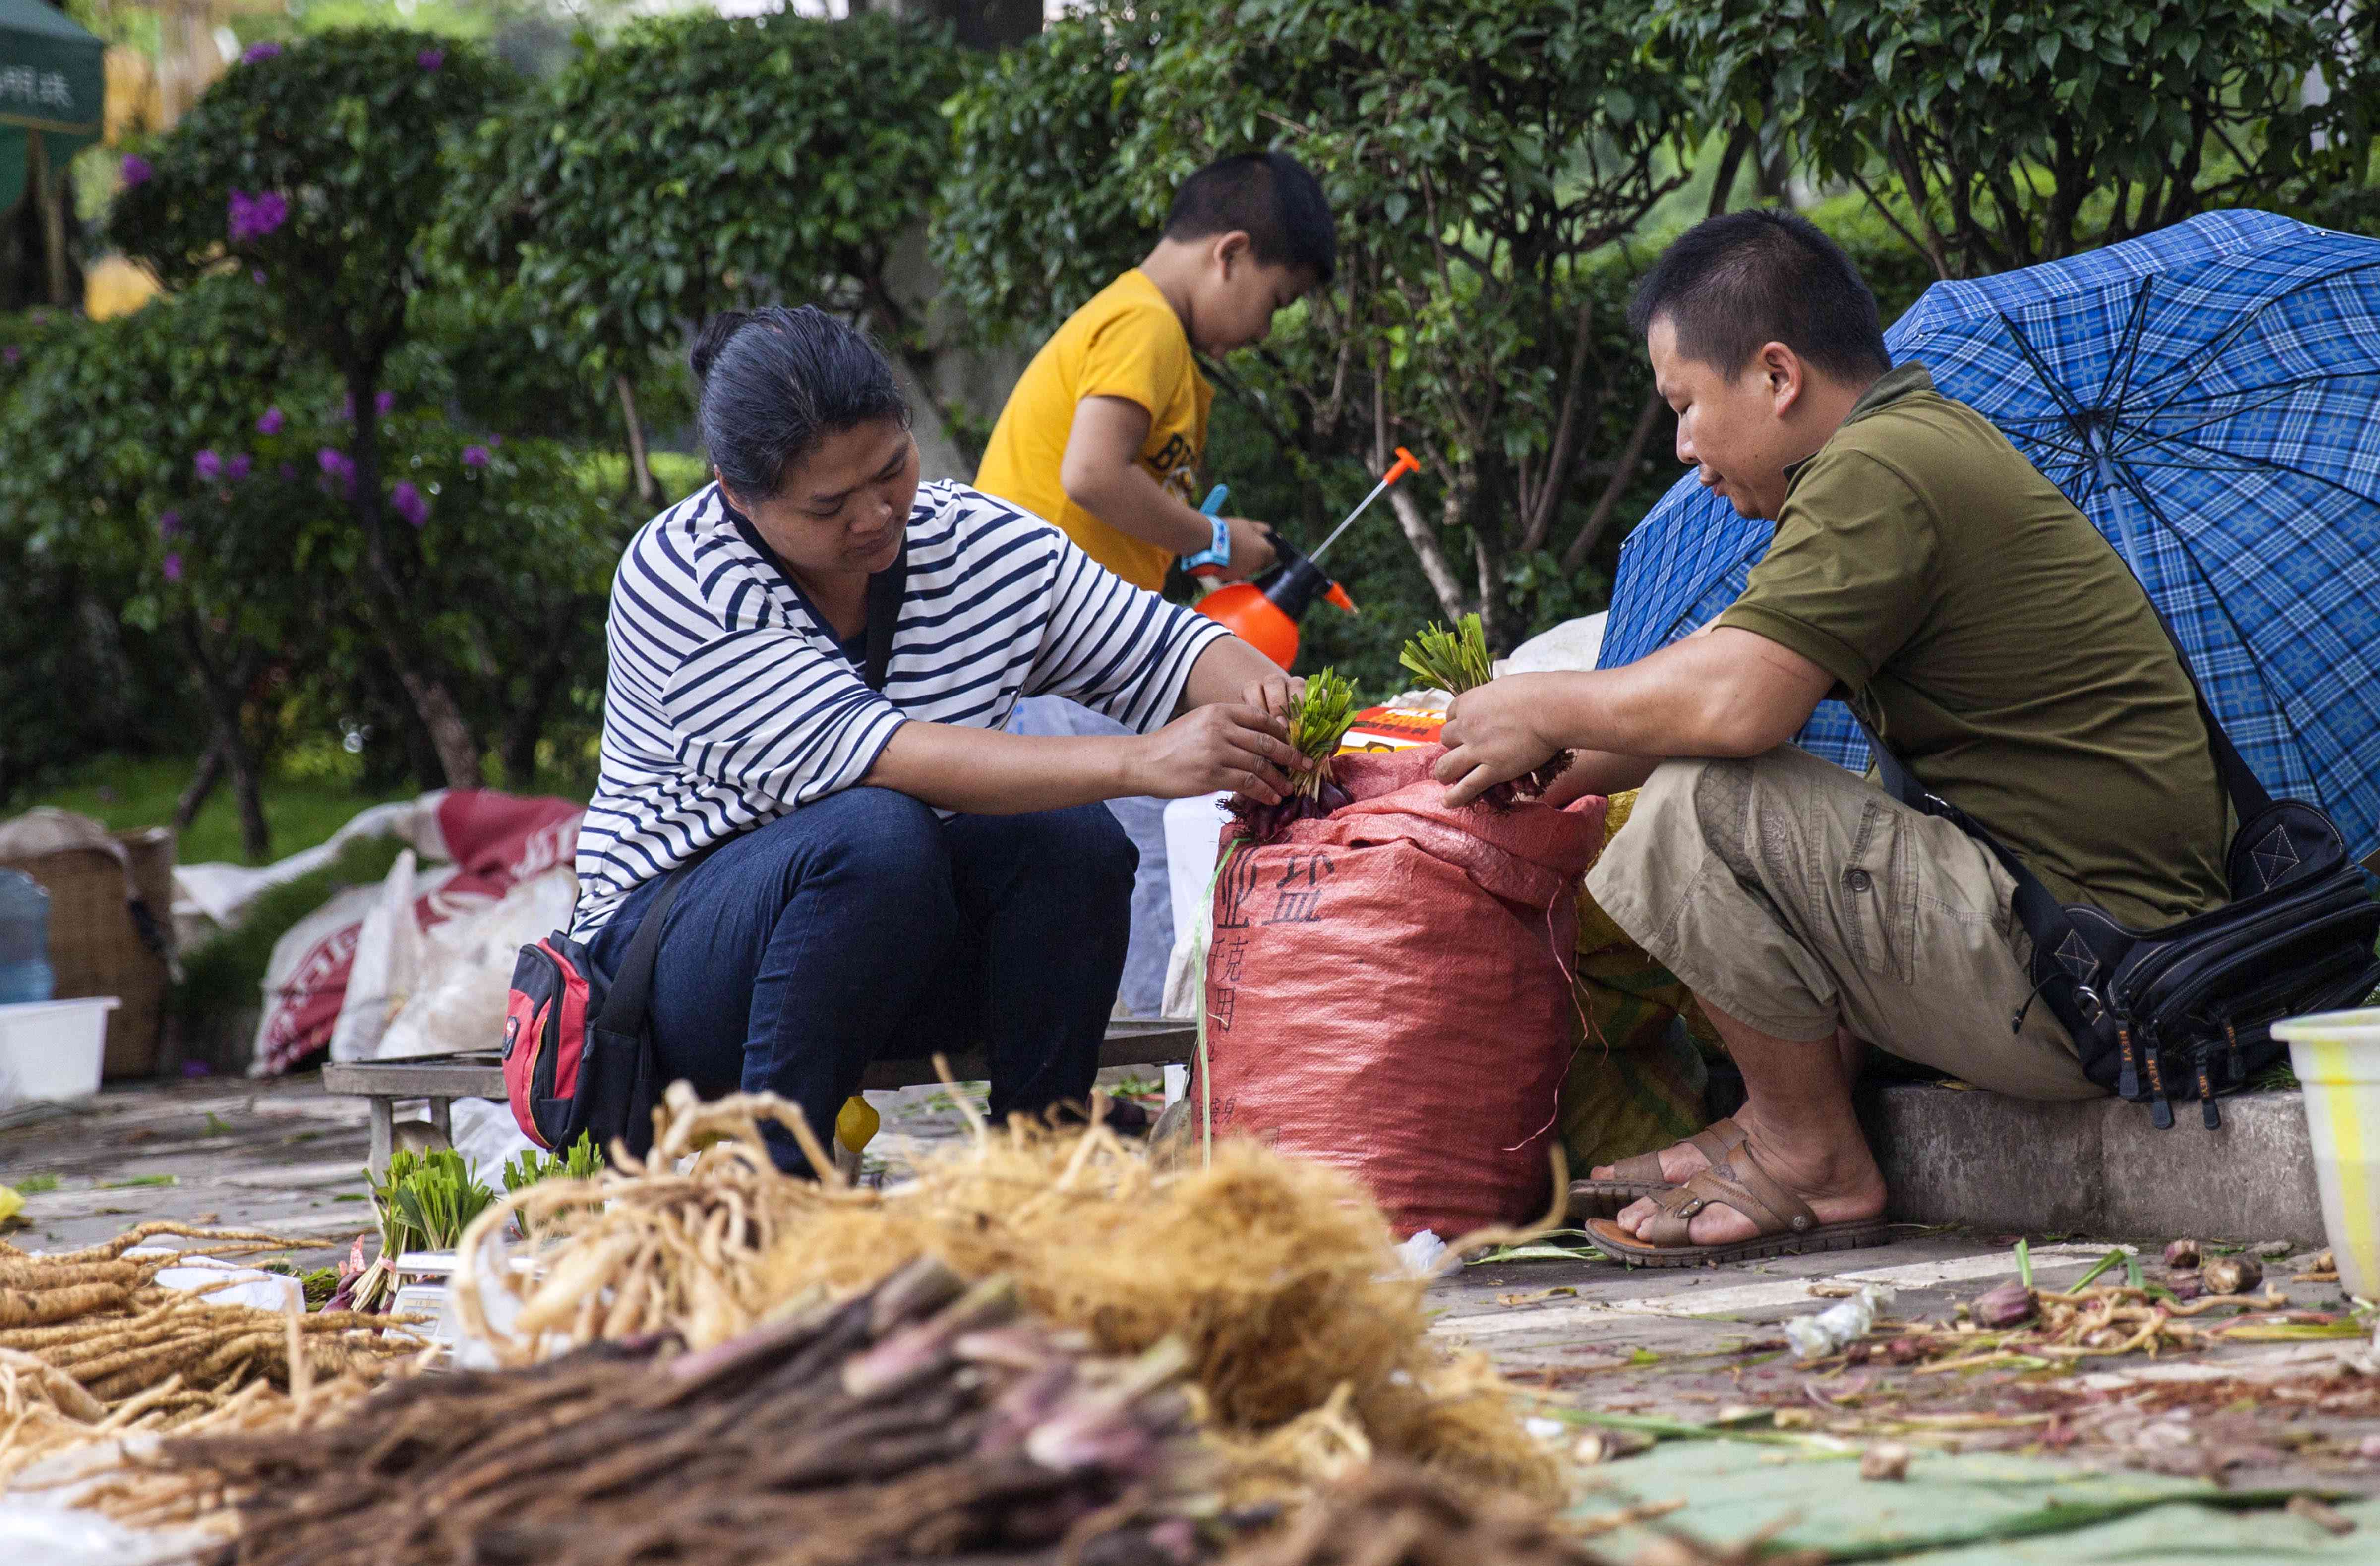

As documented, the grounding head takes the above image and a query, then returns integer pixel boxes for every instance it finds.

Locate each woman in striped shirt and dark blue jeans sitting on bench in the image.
[574,309,1292,1168]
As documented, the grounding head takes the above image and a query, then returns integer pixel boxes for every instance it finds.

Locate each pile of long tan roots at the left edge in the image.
[0,1223,421,1480]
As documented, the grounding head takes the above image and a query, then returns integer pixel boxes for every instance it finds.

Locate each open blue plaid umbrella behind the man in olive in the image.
[1602,212,2380,857]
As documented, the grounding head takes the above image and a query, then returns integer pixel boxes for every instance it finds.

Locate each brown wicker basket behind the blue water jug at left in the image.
[0,826,174,1078]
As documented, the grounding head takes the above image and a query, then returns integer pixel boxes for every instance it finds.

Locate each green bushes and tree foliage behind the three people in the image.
[0,0,2380,852]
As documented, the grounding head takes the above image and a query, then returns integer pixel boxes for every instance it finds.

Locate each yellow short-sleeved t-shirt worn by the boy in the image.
[976,267,1214,592]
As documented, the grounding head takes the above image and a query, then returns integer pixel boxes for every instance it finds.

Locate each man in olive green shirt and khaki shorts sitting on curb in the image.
[1437,212,2228,1264]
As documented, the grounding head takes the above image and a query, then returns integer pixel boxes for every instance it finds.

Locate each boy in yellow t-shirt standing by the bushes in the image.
[976,152,1338,592]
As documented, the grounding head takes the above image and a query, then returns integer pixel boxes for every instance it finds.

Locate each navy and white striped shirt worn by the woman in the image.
[574,483,1226,938]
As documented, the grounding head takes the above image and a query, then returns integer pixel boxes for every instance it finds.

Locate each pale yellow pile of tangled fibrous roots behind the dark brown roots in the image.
[455,1088,1559,1500]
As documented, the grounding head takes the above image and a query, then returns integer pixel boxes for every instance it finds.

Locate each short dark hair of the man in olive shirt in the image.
[1628,209,1892,386]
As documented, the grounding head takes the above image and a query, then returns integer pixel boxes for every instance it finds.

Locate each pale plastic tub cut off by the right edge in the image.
[2273,1009,2380,1299]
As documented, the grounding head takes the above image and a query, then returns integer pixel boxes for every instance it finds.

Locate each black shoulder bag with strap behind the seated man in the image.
[1861,685,2380,1128]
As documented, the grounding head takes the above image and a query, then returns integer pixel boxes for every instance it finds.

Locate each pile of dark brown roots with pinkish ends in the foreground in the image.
[150,1259,1228,1566]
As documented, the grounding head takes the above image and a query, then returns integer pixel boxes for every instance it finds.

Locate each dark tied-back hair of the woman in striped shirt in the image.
[688,305,909,500]
